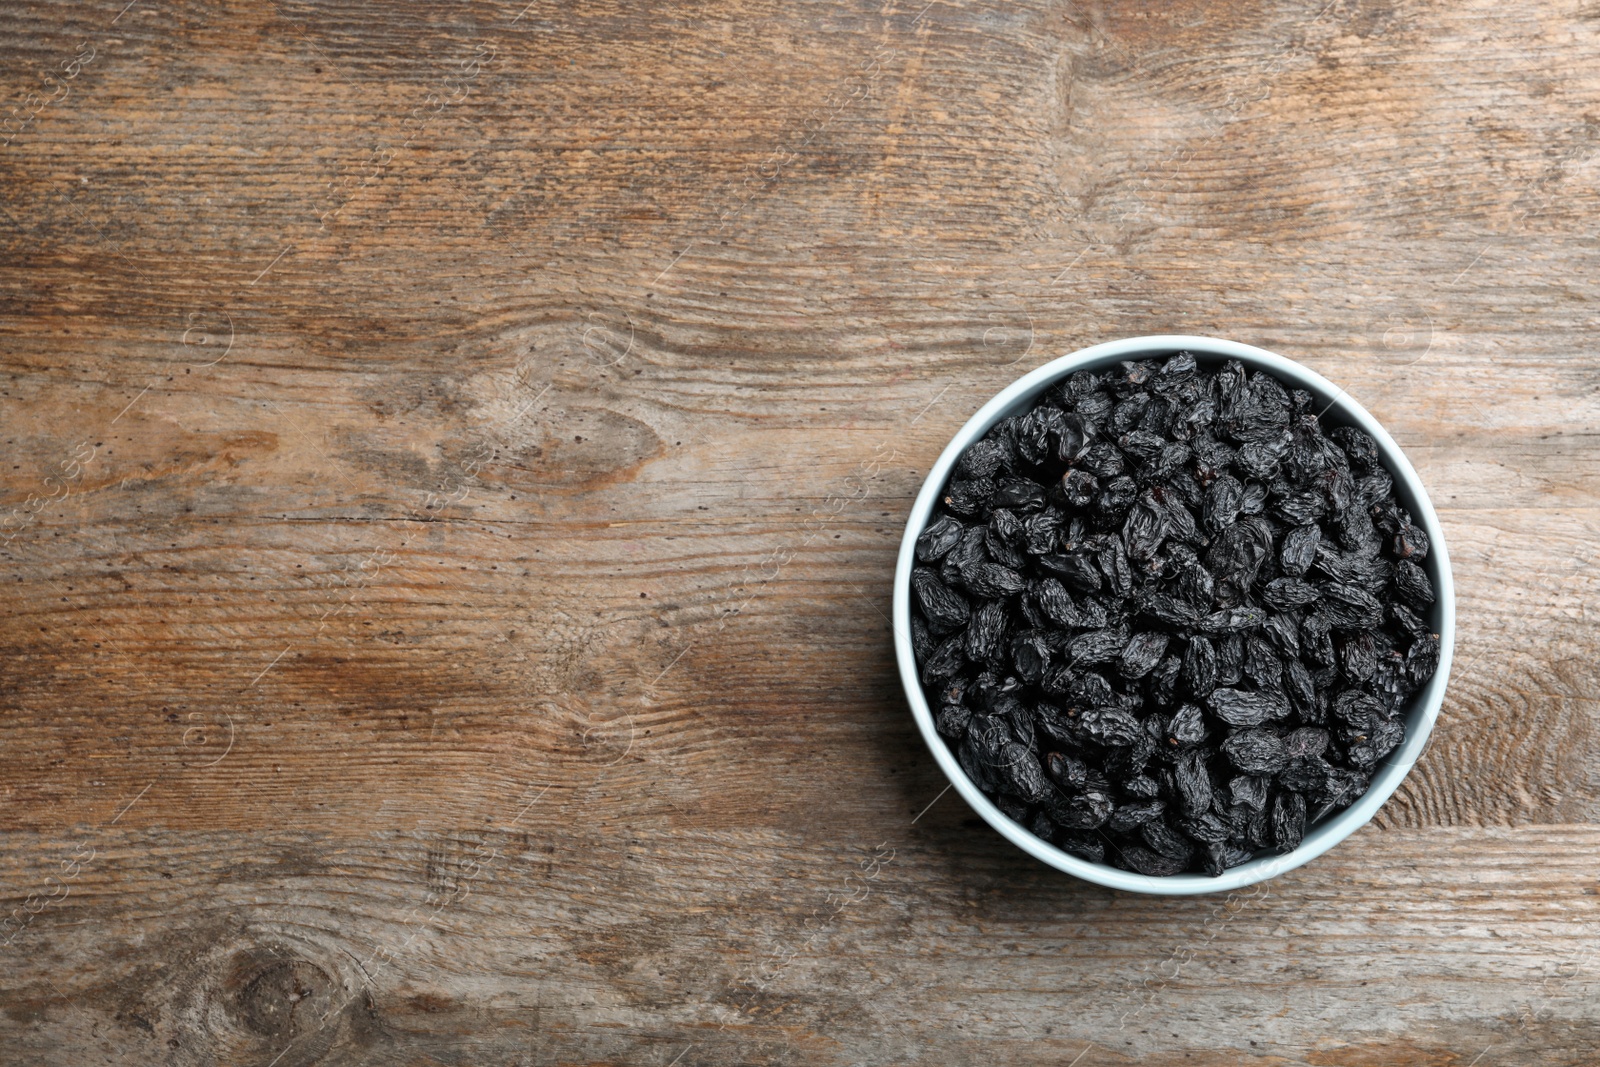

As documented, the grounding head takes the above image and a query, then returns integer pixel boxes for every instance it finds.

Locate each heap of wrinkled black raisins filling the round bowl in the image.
[910,352,1440,875]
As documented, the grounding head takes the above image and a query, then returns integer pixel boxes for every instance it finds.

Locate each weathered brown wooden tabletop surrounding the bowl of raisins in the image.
[0,0,1600,1067]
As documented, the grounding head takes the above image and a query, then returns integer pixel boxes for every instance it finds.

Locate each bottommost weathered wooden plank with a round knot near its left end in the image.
[0,831,1600,1065]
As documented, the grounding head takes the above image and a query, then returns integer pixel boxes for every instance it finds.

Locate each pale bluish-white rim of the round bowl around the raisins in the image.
[894,334,1456,894]
